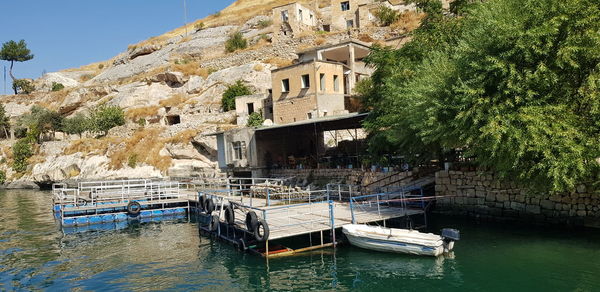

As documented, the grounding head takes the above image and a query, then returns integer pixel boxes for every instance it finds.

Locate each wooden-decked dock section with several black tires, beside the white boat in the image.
[190,178,431,257]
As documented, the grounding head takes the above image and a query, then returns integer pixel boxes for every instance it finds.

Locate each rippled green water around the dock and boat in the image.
[0,191,600,291]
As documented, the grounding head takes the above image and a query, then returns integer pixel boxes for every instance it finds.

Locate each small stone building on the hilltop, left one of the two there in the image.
[272,2,318,42]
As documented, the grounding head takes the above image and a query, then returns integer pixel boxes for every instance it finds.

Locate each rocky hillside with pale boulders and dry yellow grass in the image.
[0,0,419,187]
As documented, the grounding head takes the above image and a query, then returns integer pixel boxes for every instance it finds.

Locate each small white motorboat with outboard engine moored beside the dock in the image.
[342,224,460,256]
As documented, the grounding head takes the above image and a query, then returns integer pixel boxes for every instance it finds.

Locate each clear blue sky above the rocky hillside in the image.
[0,0,234,82]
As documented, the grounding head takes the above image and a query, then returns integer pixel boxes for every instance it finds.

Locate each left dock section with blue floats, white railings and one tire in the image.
[52,180,189,230]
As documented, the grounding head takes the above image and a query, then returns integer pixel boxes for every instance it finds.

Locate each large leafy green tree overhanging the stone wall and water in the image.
[364,0,600,191]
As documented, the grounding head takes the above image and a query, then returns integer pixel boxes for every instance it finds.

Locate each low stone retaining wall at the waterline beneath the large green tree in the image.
[435,171,600,227]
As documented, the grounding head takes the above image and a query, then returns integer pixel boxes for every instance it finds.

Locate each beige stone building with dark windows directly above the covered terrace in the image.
[271,40,373,124]
